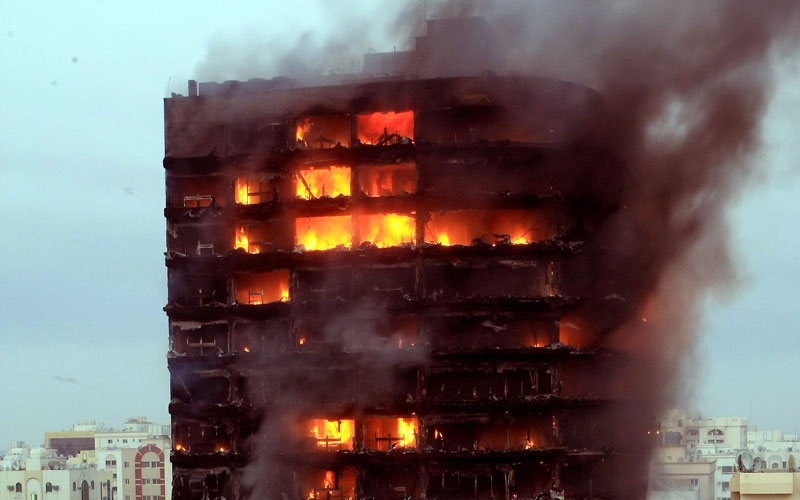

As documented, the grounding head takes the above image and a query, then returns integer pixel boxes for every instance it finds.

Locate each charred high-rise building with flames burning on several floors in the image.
[164,64,628,500]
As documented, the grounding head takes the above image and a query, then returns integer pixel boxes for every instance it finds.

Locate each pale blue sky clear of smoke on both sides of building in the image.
[0,0,800,449]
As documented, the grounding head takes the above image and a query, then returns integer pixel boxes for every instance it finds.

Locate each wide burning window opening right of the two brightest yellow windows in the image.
[425,210,553,246]
